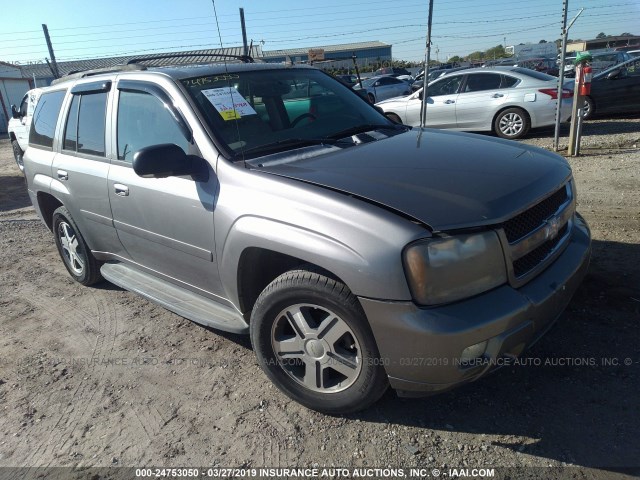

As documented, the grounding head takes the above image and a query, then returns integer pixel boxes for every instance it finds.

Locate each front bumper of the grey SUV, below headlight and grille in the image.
[360,215,591,396]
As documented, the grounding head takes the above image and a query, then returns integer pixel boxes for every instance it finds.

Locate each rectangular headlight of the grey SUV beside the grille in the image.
[404,232,507,305]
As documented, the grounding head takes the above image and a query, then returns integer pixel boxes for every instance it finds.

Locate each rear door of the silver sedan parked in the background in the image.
[456,72,508,130]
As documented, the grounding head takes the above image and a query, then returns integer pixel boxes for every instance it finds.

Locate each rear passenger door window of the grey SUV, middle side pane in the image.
[63,92,107,157]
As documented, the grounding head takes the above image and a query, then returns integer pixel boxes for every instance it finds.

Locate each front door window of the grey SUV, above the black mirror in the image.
[117,90,189,163]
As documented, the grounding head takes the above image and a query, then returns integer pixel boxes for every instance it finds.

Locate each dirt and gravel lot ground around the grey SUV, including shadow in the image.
[0,118,640,479]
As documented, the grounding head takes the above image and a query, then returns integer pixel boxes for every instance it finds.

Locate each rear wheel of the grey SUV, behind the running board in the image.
[53,207,102,286]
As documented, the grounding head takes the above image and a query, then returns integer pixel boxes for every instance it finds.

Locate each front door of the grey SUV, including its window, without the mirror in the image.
[107,80,222,296]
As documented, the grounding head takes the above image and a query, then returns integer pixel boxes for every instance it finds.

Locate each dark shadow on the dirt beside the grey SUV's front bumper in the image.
[350,241,640,474]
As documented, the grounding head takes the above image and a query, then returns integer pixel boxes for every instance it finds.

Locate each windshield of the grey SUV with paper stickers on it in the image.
[182,68,397,159]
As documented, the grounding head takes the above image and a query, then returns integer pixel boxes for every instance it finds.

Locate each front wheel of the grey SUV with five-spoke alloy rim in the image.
[250,270,388,414]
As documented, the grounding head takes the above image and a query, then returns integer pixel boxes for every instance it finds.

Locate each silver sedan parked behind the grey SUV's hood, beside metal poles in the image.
[376,67,573,139]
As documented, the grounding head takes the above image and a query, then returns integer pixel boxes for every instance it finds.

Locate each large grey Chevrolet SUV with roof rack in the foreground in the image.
[25,62,590,413]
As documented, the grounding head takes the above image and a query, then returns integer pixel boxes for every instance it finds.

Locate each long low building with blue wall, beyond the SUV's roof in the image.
[262,41,392,68]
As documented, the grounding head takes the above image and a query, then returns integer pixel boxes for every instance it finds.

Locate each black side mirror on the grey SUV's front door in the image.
[133,143,208,180]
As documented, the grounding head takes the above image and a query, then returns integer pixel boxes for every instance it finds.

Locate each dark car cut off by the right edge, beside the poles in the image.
[583,57,640,119]
